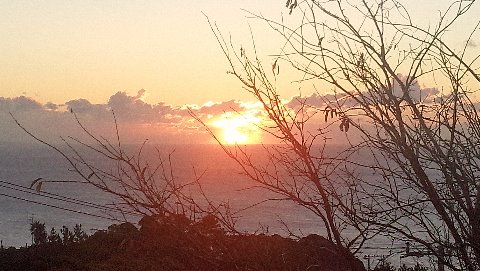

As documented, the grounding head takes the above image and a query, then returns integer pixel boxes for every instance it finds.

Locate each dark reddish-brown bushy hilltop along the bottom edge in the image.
[0,215,365,271]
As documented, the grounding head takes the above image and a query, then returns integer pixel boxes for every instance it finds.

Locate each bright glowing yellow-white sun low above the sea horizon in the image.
[213,112,260,145]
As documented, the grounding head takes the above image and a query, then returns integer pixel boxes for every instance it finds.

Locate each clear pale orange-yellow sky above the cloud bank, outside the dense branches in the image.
[0,0,480,105]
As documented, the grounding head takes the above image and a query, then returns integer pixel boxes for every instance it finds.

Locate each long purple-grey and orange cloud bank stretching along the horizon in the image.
[5,82,444,147]
